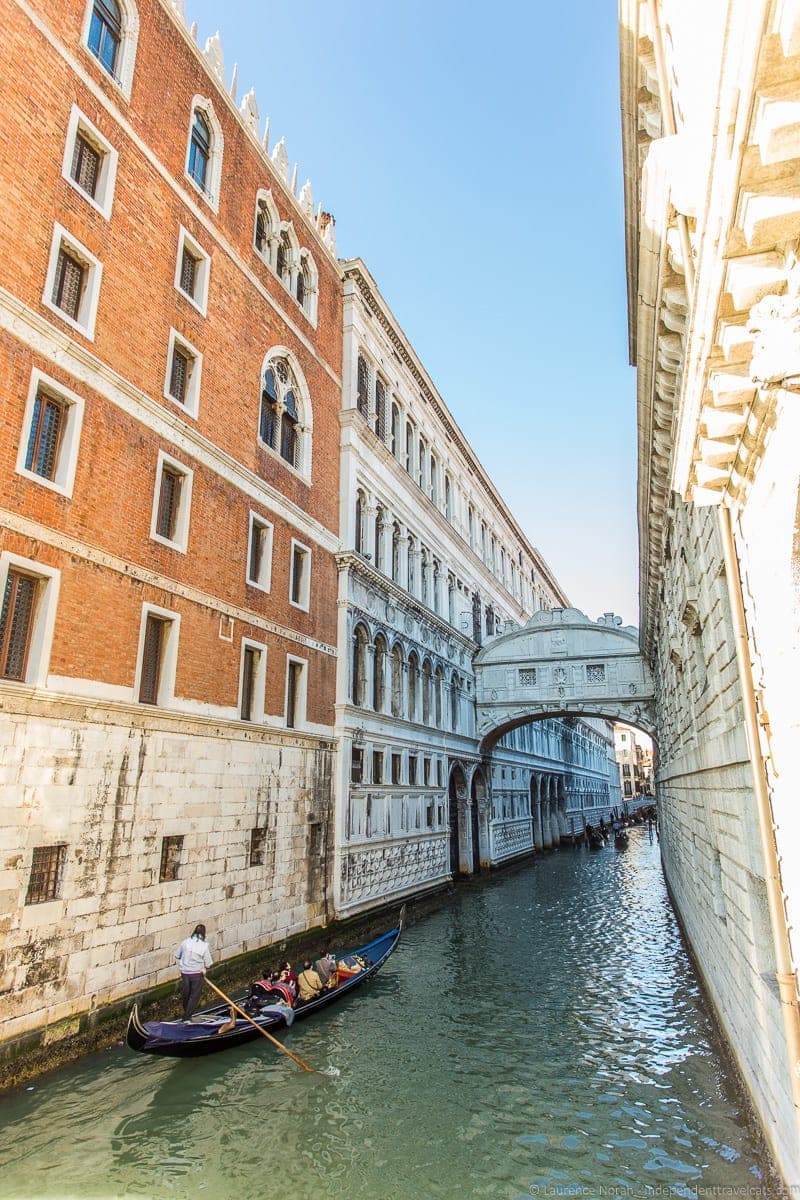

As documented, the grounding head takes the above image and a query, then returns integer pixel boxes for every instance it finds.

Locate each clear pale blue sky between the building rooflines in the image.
[186,0,638,623]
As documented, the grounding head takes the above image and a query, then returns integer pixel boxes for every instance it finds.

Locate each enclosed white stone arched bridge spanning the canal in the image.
[474,608,655,751]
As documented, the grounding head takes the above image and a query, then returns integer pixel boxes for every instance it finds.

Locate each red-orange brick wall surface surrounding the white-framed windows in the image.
[0,0,342,722]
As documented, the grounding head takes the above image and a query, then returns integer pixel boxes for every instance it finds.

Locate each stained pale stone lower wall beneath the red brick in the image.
[0,692,333,1038]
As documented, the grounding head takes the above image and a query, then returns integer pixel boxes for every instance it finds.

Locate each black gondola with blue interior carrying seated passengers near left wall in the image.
[126,912,403,1058]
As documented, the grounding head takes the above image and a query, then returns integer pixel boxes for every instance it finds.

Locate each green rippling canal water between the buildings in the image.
[0,830,768,1200]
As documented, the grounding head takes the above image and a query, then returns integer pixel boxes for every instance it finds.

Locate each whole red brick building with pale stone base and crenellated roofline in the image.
[0,0,342,1038]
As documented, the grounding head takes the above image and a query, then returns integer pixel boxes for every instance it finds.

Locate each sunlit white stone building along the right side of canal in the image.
[621,0,800,1187]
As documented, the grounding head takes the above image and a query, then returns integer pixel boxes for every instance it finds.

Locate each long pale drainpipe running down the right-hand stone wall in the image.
[717,504,800,1132]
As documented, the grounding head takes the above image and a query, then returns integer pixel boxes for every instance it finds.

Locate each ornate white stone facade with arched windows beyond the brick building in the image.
[335,260,619,913]
